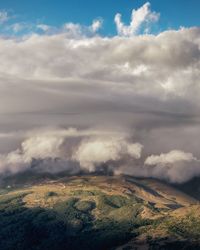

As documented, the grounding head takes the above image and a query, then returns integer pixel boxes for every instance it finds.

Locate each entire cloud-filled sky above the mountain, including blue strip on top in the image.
[0,0,200,183]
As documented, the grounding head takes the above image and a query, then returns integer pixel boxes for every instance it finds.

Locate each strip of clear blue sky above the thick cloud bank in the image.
[0,0,200,35]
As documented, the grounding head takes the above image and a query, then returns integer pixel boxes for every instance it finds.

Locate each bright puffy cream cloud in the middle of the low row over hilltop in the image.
[73,137,143,171]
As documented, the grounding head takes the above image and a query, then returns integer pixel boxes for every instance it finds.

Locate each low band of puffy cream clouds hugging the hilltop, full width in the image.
[0,128,200,183]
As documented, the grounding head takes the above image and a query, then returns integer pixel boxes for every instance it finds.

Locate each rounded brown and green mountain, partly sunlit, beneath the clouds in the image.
[0,173,200,250]
